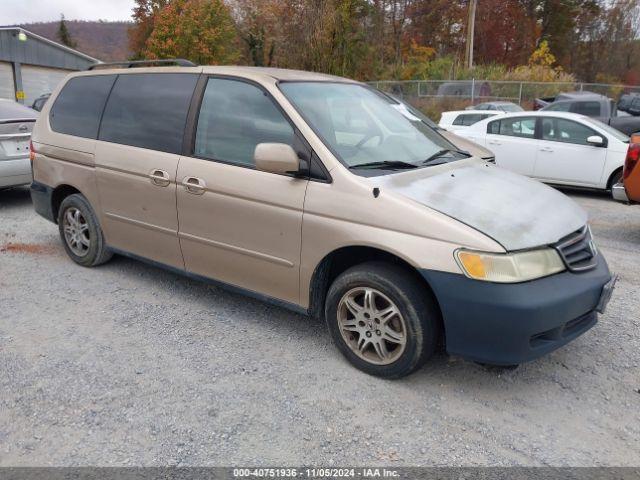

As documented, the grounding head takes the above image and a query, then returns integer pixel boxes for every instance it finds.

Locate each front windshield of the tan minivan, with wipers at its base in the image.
[280,82,466,168]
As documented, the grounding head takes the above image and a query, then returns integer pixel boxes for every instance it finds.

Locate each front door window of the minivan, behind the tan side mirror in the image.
[194,78,296,166]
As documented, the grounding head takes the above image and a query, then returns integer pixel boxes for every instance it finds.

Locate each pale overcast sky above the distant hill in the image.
[0,0,134,25]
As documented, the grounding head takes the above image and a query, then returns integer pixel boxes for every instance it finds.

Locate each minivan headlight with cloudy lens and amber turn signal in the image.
[455,248,565,283]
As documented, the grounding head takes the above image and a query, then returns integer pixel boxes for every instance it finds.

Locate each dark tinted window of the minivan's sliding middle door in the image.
[100,73,198,153]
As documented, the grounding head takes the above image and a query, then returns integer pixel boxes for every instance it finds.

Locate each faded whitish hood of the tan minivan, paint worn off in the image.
[370,159,587,251]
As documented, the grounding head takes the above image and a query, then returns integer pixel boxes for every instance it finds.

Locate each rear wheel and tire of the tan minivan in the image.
[58,193,113,267]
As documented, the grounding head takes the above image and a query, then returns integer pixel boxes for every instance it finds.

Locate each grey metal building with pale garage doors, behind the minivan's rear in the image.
[0,27,100,105]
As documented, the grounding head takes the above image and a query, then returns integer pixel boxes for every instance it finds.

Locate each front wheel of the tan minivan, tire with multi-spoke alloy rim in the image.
[325,262,441,379]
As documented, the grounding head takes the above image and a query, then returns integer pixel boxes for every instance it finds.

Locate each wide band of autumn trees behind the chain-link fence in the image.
[130,0,640,81]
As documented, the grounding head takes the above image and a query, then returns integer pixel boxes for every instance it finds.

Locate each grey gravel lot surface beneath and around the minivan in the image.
[0,189,640,467]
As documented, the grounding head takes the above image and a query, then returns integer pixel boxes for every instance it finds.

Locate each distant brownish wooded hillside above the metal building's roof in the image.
[21,20,131,62]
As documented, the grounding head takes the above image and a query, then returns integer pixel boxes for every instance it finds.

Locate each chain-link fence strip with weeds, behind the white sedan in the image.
[369,79,640,121]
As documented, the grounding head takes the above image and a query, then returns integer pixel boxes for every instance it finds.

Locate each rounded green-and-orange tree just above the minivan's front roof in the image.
[144,0,239,65]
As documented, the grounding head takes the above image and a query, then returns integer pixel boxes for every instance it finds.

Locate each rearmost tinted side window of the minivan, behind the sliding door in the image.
[50,75,116,139]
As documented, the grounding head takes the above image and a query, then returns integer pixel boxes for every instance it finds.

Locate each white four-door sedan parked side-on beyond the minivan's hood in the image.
[456,112,629,194]
